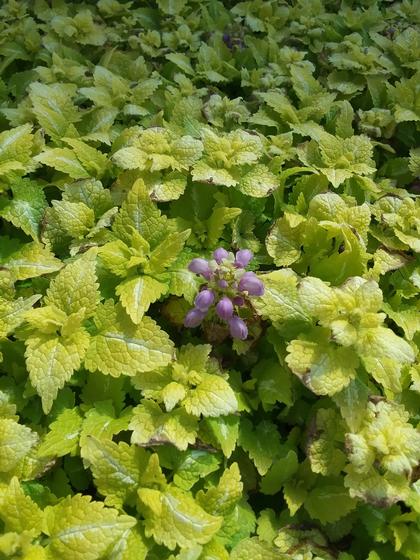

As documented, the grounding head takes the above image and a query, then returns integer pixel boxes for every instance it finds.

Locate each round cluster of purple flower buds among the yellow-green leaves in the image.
[184,247,264,340]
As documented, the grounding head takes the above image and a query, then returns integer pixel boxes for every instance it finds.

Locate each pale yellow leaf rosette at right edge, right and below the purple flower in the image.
[286,277,415,395]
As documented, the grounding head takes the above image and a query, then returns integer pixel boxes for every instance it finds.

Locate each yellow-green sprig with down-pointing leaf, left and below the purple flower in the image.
[23,249,173,412]
